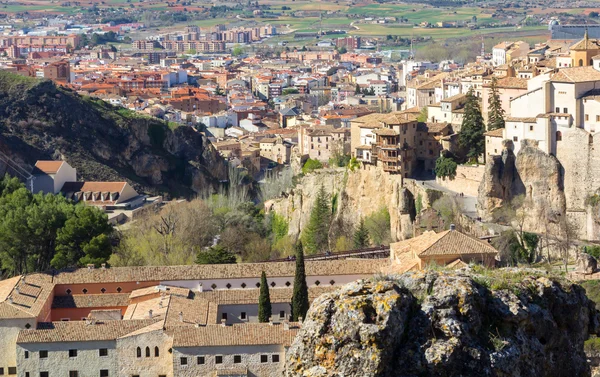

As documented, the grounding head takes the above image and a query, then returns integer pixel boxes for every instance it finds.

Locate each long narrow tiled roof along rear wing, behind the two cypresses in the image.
[45,259,387,284]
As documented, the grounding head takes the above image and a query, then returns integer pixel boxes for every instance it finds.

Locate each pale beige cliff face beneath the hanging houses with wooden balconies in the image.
[265,167,414,240]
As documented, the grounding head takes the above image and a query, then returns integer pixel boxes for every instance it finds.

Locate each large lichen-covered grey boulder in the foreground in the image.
[285,270,600,377]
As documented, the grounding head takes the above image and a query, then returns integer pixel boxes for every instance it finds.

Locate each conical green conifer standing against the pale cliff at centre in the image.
[302,185,331,254]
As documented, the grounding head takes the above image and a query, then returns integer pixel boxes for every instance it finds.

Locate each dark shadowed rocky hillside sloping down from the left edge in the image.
[0,71,227,196]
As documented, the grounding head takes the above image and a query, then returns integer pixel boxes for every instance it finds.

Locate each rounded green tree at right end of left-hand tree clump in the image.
[50,205,113,269]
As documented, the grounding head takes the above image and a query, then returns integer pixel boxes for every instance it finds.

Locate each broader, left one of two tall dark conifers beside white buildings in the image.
[458,88,485,161]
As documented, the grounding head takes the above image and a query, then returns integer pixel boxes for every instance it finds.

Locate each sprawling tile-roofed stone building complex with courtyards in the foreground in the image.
[0,259,389,377]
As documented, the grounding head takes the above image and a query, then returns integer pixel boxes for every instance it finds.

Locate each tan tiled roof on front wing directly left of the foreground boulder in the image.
[173,323,299,347]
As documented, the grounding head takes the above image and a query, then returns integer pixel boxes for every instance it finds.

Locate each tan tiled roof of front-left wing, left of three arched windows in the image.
[17,320,156,343]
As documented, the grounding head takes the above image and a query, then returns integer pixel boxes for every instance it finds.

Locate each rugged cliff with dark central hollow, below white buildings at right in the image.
[477,140,566,233]
